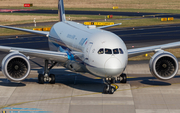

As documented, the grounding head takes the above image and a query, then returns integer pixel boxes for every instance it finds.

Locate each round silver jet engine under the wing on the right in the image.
[149,50,179,80]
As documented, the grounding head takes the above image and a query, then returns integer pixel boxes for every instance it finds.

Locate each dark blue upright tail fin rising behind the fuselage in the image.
[58,0,66,22]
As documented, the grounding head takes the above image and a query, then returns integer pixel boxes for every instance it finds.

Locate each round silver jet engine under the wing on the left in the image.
[2,52,30,81]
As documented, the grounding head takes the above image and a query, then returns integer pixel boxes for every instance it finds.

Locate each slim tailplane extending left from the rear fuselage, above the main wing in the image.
[0,25,49,37]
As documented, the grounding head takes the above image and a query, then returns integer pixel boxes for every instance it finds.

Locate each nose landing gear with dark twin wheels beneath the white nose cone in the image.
[103,78,116,94]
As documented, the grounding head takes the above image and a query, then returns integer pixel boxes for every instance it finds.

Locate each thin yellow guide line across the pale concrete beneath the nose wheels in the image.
[0,83,180,109]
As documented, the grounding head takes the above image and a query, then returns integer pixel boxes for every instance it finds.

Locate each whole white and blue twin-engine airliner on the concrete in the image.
[0,0,180,94]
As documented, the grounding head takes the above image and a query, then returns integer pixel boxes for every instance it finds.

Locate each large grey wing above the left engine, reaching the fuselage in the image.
[0,46,68,62]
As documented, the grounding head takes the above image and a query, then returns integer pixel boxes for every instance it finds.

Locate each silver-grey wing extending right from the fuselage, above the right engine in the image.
[128,42,180,58]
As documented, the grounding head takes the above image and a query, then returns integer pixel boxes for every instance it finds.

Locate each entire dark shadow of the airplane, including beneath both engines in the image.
[0,68,180,92]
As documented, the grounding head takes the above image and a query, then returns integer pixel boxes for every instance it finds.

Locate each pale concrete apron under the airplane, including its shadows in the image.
[0,59,180,113]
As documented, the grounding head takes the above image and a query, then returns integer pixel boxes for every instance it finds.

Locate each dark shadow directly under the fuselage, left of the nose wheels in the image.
[27,68,104,92]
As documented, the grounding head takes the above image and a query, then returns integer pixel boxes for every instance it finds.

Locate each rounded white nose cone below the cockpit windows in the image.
[104,58,123,76]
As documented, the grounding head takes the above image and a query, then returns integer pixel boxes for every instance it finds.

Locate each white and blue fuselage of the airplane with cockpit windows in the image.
[49,21,128,77]
